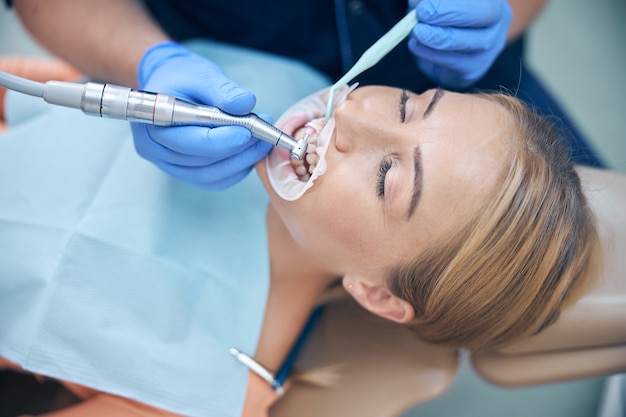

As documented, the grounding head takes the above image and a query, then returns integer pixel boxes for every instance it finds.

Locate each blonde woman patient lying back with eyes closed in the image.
[0,87,599,416]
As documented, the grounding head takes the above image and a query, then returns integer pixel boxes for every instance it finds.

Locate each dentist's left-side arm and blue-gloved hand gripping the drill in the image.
[13,0,271,190]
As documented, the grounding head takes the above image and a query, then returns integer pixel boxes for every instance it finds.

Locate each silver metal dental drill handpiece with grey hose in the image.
[0,71,307,160]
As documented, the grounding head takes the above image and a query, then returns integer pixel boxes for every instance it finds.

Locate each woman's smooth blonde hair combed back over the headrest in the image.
[387,94,600,350]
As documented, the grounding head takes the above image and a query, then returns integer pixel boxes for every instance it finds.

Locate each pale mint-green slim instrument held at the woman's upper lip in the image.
[326,10,417,121]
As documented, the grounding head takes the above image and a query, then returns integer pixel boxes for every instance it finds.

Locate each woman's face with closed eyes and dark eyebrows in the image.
[257,87,508,276]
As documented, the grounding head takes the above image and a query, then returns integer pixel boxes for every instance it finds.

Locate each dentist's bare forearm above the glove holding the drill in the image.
[13,0,168,87]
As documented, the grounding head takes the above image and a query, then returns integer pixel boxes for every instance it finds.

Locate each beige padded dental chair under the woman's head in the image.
[270,167,626,417]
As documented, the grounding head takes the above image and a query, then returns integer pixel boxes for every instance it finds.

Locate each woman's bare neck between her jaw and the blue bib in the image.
[255,206,339,369]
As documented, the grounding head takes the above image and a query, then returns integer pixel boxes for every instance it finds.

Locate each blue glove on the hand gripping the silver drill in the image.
[131,42,272,190]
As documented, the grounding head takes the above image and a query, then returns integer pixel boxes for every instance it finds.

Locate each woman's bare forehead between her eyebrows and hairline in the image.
[404,93,511,237]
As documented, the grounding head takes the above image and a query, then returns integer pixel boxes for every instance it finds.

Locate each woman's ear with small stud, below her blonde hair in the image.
[343,275,415,323]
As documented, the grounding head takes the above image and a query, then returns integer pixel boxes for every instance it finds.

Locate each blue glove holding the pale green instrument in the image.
[409,0,513,88]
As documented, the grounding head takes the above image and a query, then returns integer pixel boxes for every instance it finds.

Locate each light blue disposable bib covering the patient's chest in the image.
[0,96,269,416]
